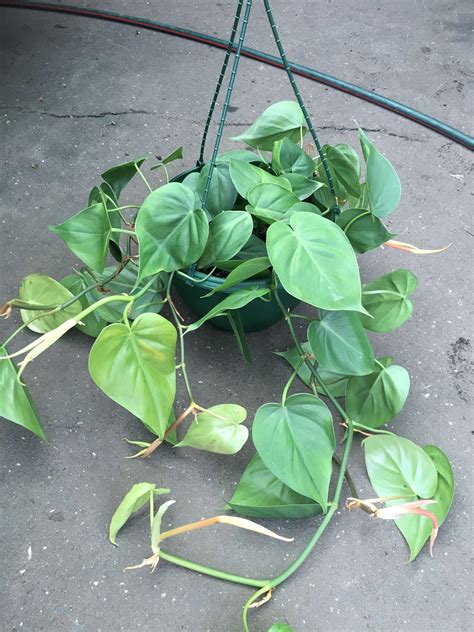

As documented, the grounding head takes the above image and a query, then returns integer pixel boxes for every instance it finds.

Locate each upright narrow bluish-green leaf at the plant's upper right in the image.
[359,129,402,217]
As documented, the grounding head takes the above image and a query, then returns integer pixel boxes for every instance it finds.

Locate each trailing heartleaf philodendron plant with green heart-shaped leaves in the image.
[0,101,454,630]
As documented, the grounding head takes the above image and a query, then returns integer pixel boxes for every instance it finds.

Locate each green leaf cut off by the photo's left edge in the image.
[0,346,46,440]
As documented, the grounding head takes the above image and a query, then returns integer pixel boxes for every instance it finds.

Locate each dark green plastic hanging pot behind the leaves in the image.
[173,270,300,331]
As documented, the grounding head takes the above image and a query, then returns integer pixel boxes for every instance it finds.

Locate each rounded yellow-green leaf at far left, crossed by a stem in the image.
[18,274,82,334]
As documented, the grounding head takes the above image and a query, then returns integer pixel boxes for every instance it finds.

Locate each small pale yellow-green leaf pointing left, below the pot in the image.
[176,404,249,454]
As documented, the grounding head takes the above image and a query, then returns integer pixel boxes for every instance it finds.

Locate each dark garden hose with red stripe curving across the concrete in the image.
[0,0,474,151]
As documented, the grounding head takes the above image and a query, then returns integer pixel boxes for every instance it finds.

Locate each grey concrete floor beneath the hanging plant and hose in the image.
[0,0,474,632]
